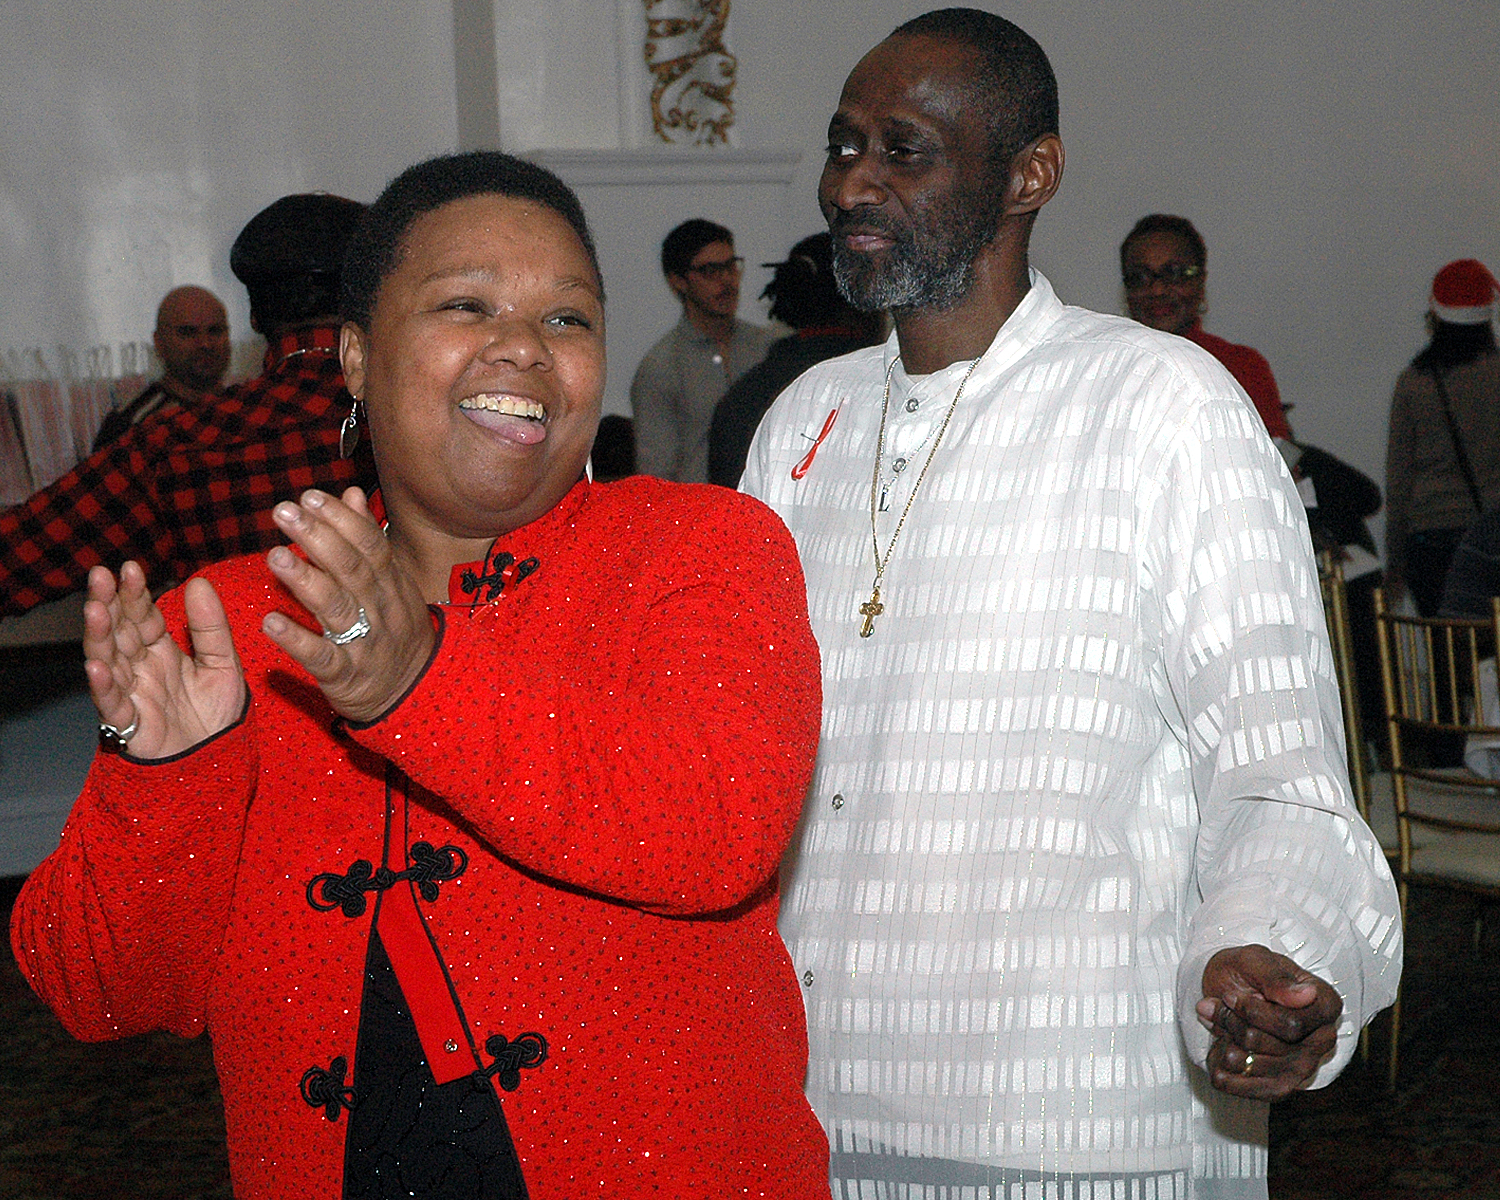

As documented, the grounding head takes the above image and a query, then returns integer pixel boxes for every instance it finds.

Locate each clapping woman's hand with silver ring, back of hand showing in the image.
[261,488,437,722]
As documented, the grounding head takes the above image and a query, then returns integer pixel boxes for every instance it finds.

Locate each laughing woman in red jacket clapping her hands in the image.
[12,152,828,1200]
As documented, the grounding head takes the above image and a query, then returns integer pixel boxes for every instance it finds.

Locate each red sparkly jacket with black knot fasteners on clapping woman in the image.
[12,479,828,1200]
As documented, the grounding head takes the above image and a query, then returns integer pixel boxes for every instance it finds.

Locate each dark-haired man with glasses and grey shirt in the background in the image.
[630,218,776,483]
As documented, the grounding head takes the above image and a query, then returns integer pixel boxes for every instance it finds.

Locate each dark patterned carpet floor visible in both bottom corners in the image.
[0,881,1500,1200]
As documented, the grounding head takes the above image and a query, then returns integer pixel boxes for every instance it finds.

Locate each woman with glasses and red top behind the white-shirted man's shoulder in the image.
[1121,213,1292,441]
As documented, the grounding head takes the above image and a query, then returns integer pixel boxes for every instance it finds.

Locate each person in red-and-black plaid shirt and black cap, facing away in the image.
[0,194,375,617]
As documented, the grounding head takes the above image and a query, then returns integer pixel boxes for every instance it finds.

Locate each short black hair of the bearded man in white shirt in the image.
[891,9,1058,171]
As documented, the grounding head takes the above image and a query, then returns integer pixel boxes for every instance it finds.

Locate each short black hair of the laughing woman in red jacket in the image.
[342,150,603,329]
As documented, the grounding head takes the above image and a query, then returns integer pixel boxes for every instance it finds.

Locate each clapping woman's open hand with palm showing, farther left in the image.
[84,563,245,759]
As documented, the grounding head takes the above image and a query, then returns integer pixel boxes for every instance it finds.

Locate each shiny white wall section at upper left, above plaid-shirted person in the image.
[0,0,455,361]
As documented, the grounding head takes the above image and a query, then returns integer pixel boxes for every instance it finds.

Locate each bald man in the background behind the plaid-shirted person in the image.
[93,284,230,450]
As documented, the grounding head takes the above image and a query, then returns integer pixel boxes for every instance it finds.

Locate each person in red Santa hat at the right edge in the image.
[1386,258,1500,617]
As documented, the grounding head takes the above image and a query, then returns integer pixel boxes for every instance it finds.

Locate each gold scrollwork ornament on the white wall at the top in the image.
[645,0,737,146]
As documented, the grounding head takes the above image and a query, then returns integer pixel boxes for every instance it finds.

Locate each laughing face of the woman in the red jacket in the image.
[342,192,605,540]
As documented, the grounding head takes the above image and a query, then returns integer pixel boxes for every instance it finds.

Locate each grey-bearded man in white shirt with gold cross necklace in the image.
[741,9,1401,1200]
